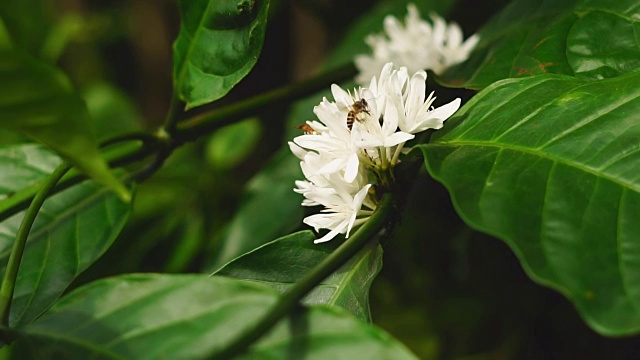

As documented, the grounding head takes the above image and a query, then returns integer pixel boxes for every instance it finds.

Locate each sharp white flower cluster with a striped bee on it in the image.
[289,63,460,243]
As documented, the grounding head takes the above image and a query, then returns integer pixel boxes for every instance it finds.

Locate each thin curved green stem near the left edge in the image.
[0,163,71,327]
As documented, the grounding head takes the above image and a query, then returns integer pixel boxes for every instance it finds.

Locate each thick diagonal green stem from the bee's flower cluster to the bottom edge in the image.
[211,193,394,360]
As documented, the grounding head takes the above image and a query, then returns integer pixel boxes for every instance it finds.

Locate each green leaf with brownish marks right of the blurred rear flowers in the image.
[439,0,578,89]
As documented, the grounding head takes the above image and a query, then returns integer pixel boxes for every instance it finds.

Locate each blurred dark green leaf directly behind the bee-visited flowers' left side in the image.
[208,148,303,271]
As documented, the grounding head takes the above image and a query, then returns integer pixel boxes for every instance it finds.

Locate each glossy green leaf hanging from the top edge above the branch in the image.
[173,0,269,109]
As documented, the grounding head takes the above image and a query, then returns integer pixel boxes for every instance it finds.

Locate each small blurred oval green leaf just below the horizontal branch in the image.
[207,118,262,170]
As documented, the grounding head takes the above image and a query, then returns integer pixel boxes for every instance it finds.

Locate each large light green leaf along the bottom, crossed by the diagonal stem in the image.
[17,274,414,359]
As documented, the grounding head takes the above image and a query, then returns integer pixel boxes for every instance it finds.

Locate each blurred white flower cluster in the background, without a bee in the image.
[355,4,480,85]
